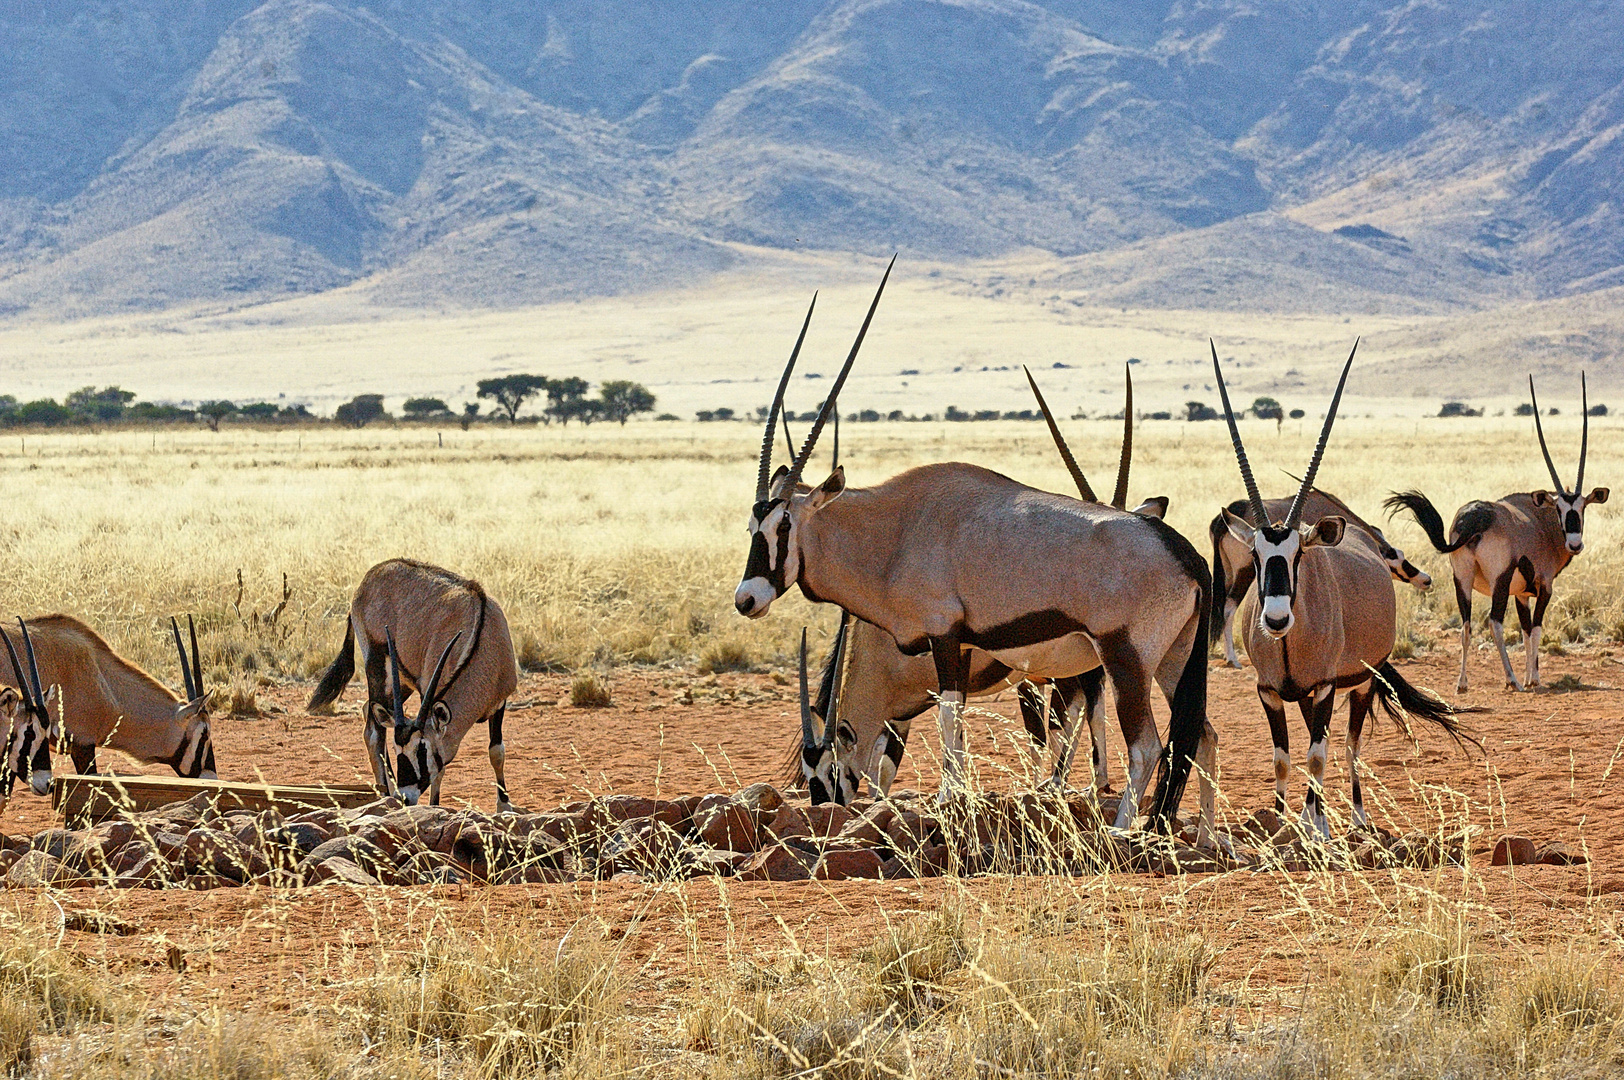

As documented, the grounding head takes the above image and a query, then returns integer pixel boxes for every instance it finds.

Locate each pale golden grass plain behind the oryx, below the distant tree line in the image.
[0,416,1604,685]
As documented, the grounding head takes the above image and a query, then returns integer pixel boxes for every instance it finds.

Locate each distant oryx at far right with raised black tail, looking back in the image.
[1385,372,1608,693]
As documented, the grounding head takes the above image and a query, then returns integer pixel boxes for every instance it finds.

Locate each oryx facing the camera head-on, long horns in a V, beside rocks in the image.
[1213,341,1462,836]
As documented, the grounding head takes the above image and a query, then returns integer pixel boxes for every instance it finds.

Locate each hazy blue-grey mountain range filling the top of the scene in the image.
[0,0,1624,317]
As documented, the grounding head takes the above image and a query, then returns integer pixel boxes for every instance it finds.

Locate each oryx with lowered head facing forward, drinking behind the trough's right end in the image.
[305,559,518,814]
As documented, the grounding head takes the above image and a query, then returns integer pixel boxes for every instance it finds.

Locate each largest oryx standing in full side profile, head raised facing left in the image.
[734,260,1212,828]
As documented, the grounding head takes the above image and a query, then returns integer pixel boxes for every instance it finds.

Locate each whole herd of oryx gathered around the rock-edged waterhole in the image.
[0,260,1608,840]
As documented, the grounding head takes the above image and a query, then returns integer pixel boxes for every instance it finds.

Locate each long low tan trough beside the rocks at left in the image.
[50,773,378,827]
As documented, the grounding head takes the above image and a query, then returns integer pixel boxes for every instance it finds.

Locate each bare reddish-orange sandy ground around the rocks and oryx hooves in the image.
[0,648,1624,1018]
